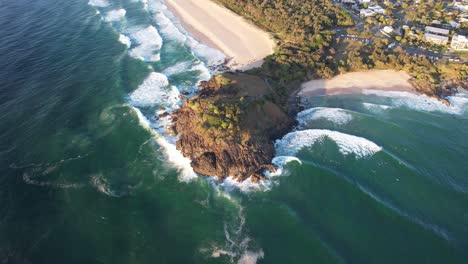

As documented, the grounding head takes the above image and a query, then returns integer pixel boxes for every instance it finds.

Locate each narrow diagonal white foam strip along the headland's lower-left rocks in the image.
[132,107,197,182]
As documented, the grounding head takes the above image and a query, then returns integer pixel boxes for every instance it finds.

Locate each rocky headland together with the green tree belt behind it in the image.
[171,0,468,181]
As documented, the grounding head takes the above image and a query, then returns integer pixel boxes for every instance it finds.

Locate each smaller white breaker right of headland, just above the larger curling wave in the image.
[297,107,353,126]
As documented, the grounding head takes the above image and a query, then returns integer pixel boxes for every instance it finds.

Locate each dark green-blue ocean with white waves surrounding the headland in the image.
[0,0,468,264]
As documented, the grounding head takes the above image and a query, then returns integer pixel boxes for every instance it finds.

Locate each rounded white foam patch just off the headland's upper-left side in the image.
[130,72,180,109]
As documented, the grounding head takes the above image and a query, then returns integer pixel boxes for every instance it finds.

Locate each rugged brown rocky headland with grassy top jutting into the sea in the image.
[170,73,294,181]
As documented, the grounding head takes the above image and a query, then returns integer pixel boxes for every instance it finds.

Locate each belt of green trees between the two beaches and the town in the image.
[216,0,468,99]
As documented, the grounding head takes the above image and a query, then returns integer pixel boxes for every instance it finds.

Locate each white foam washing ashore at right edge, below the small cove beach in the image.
[363,90,468,115]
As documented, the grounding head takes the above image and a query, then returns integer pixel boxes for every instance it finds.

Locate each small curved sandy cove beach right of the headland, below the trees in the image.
[298,70,415,96]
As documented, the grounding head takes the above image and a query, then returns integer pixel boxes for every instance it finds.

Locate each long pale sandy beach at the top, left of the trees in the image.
[166,0,275,70]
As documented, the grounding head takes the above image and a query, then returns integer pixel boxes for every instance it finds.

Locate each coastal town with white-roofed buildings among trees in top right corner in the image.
[336,0,468,63]
